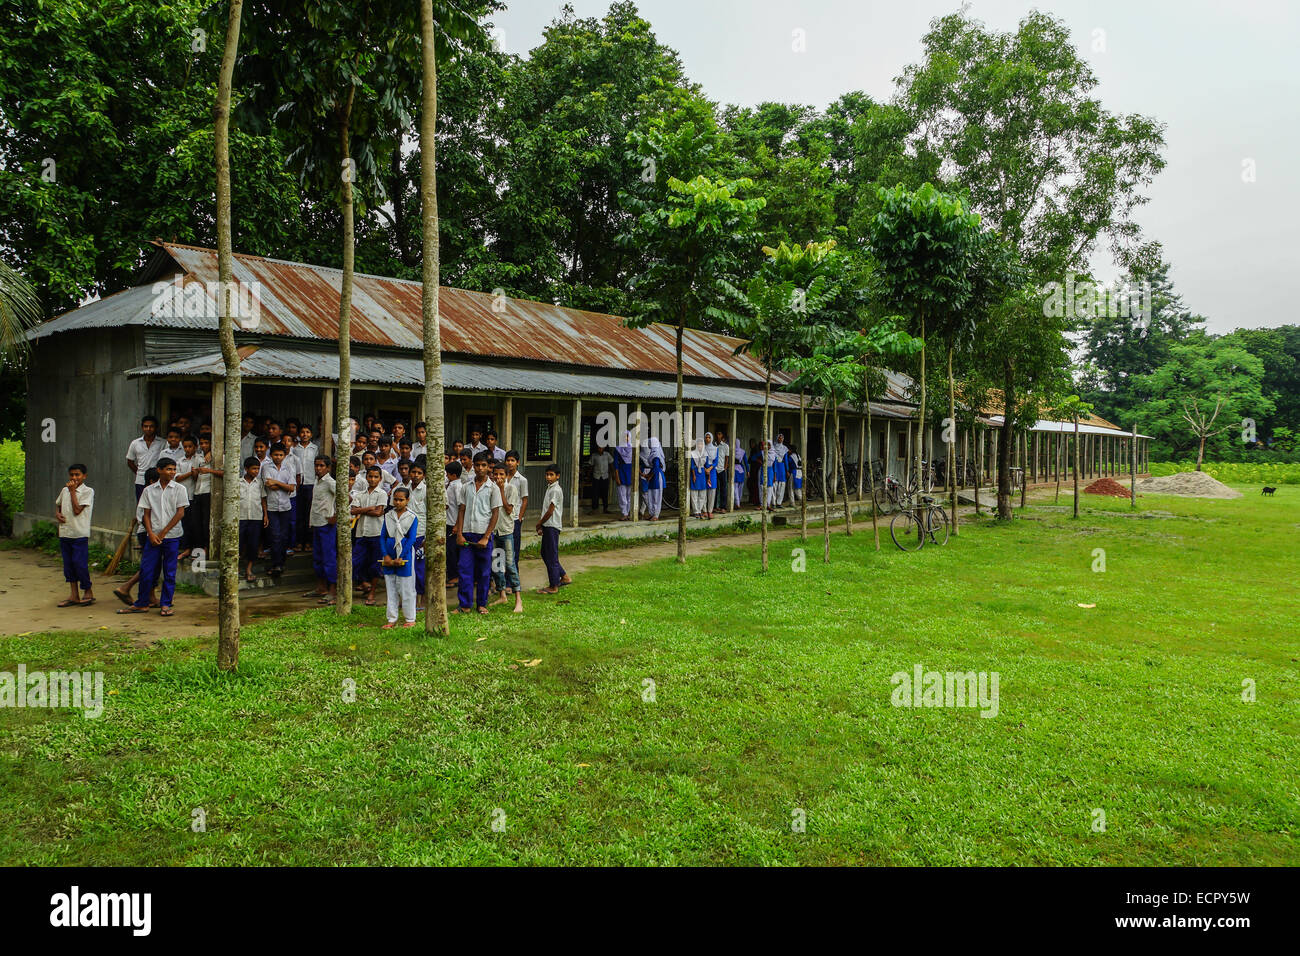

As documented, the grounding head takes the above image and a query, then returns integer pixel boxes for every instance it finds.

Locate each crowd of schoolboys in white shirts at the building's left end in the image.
[55,415,571,627]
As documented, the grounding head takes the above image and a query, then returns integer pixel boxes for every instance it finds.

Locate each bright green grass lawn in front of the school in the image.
[0,486,1300,865]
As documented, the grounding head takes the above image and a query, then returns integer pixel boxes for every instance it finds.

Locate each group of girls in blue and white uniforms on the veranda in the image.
[592,428,803,522]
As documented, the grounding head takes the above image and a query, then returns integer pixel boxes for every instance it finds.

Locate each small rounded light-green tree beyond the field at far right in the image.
[1136,334,1274,471]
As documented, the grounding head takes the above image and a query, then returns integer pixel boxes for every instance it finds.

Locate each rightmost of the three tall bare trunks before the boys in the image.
[420,0,452,636]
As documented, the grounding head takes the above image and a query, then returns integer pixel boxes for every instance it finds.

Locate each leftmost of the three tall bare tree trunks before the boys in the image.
[213,0,243,671]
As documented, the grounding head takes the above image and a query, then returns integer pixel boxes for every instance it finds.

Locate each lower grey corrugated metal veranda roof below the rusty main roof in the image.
[127,346,906,418]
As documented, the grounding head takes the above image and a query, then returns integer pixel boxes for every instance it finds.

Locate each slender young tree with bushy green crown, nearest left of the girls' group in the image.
[620,174,763,563]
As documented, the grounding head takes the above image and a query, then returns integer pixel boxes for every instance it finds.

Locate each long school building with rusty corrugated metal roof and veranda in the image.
[14,242,1145,546]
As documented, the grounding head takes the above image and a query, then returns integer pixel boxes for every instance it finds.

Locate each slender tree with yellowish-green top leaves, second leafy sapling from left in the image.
[716,239,841,571]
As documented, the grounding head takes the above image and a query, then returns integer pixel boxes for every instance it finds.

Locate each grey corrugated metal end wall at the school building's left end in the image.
[14,328,156,548]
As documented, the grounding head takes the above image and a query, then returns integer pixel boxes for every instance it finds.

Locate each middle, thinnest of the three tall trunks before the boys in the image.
[334,93,356,614]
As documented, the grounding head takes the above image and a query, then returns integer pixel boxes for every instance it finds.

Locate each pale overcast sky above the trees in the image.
[497,0,1300,332]
